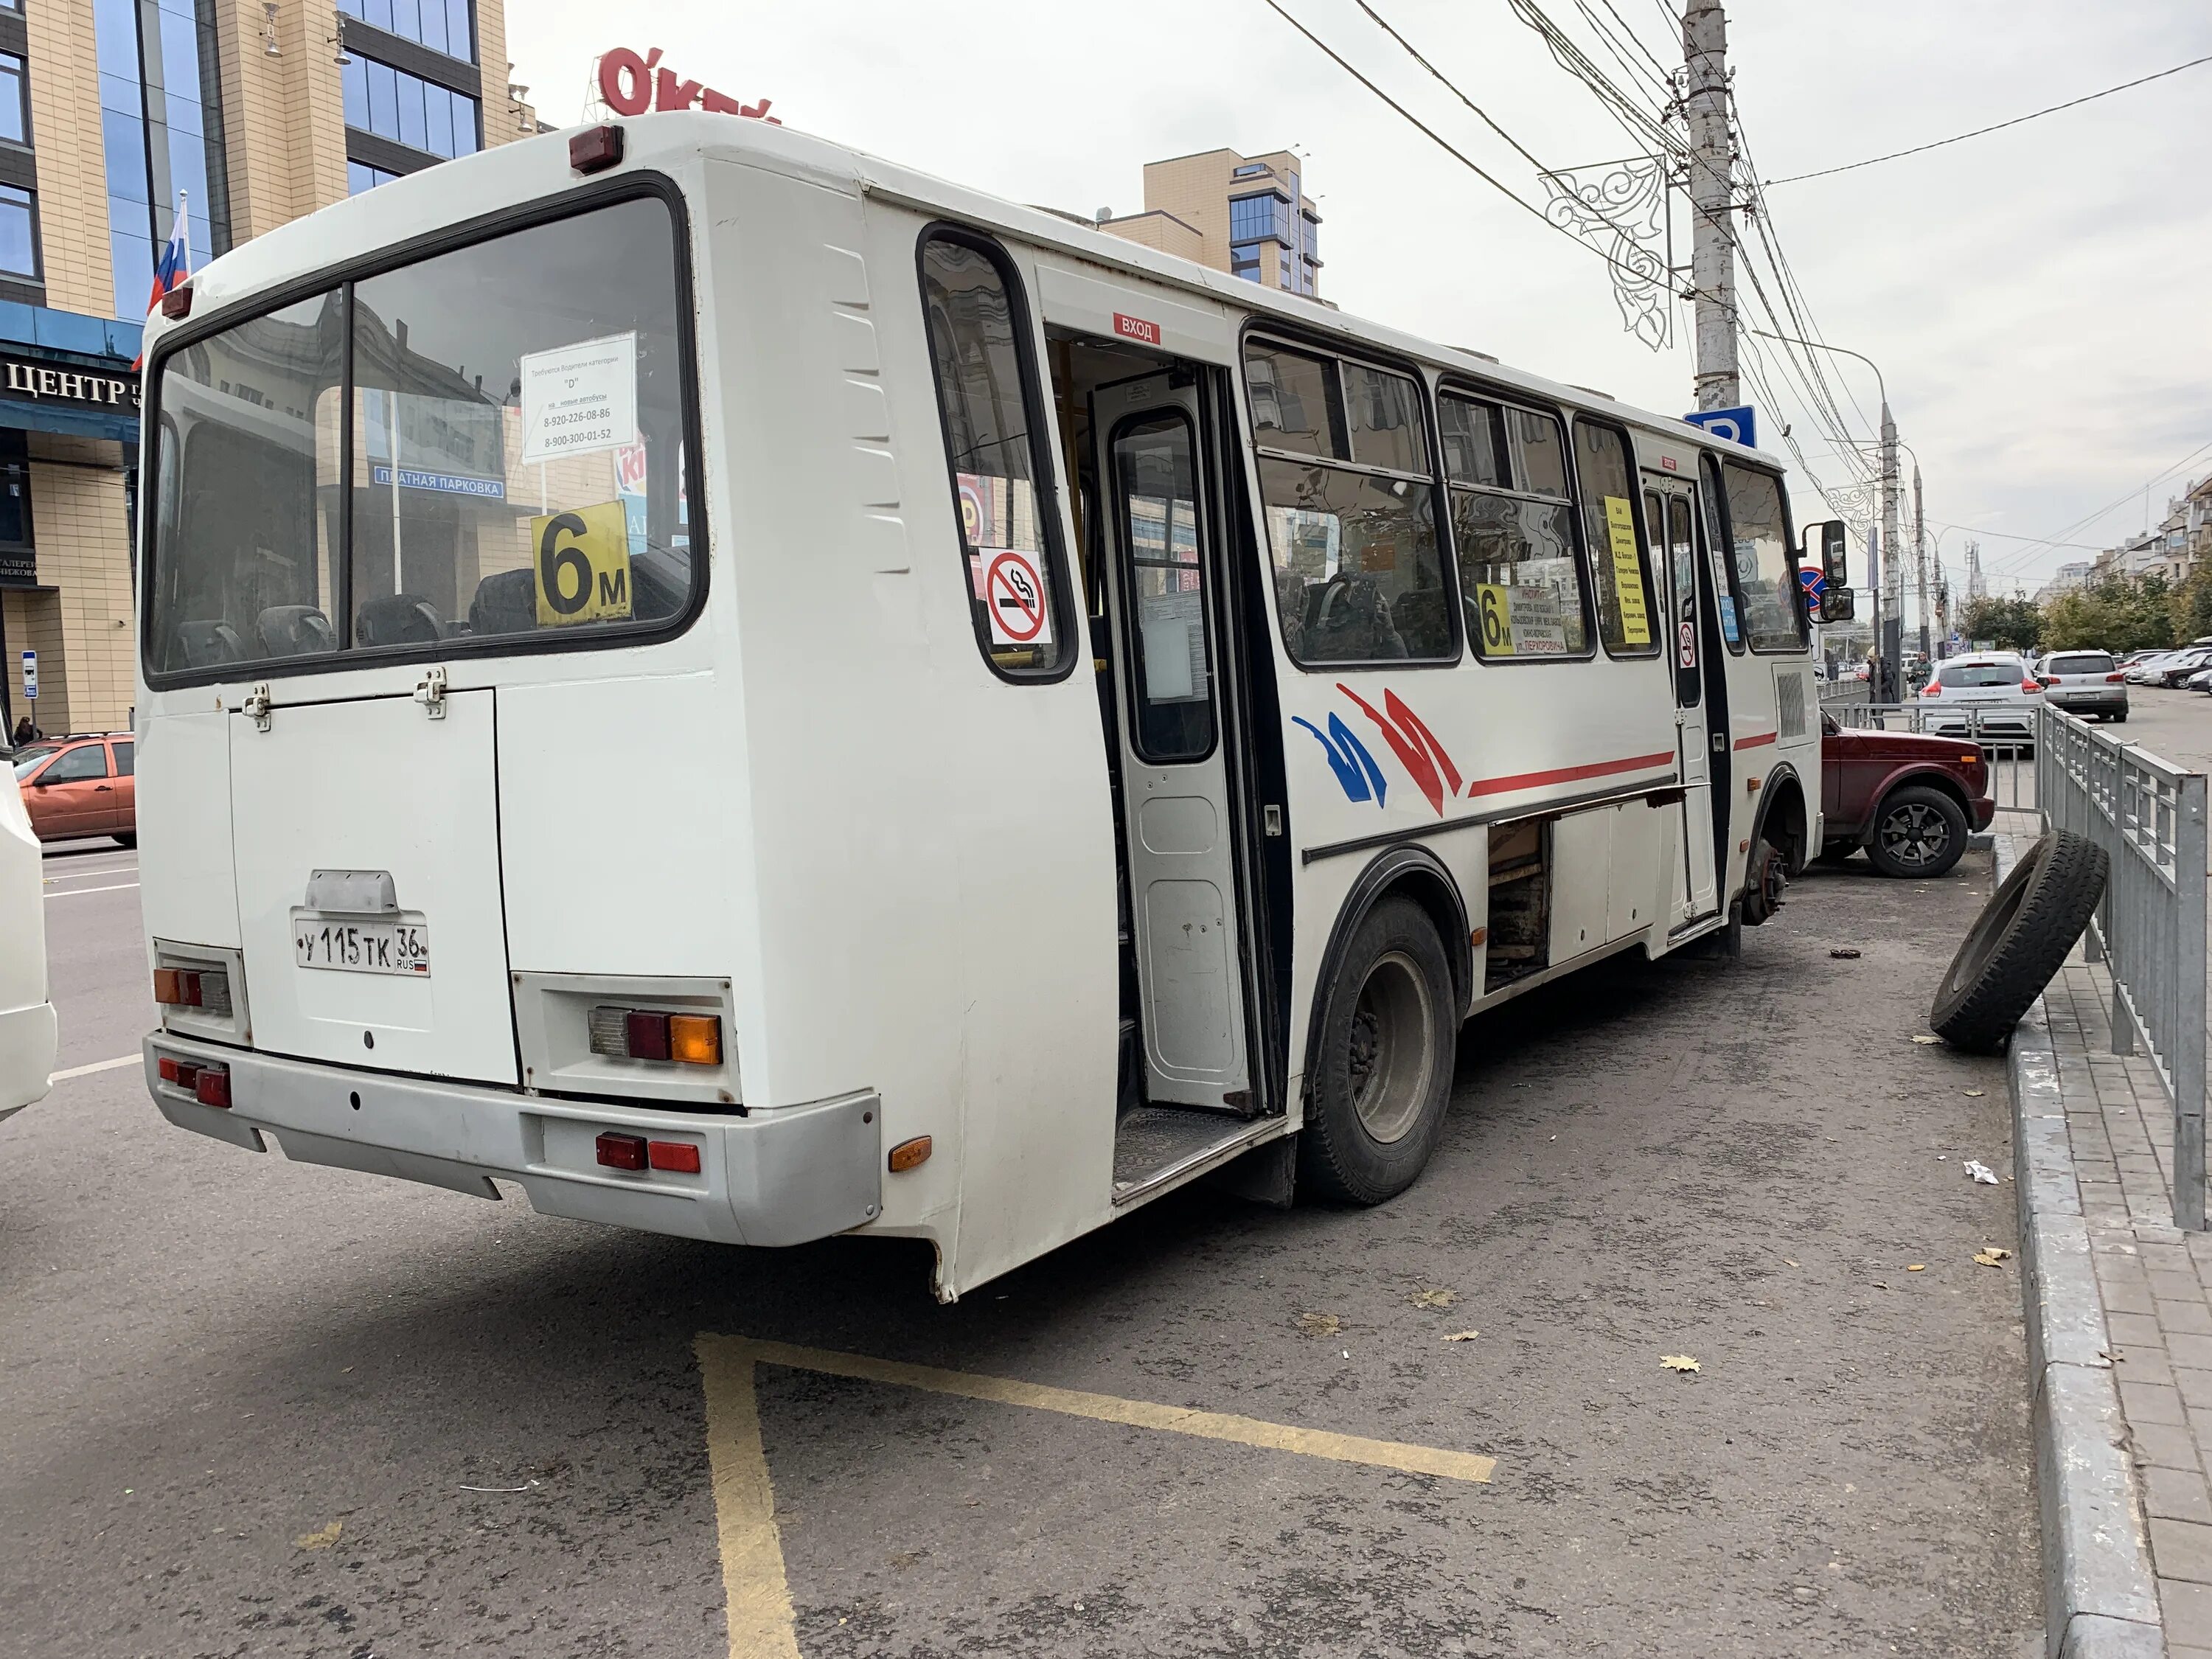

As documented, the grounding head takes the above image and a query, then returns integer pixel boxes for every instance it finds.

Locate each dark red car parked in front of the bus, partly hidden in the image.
[1820,714,1997,878]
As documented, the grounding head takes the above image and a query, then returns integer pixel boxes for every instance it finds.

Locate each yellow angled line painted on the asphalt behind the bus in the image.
[692,1332,1498,1659]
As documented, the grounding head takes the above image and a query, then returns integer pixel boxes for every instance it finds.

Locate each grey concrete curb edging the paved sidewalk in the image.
[1995,836,2166,1659]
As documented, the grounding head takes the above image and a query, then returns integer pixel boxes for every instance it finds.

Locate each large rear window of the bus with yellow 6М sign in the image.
[146,197,697,677]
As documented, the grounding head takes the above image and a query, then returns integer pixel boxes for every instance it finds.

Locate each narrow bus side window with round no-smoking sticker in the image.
[922,228,1075,679]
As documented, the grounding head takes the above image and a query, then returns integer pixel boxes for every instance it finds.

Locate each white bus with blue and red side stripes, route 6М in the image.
[137,115,1840,1298]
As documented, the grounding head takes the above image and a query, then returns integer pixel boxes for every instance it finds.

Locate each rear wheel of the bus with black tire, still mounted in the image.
[1298,896,1460,1203]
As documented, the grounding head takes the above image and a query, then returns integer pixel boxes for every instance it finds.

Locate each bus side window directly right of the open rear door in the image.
[1245,341,1458,668]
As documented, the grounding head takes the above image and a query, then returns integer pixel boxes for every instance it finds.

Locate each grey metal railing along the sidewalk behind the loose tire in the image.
[2035,708,2205,1232]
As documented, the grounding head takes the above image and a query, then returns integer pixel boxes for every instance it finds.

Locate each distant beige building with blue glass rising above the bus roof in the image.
[1099,150,1321,299]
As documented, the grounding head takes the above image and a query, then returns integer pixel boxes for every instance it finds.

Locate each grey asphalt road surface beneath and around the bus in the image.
[0,852,2042,1659]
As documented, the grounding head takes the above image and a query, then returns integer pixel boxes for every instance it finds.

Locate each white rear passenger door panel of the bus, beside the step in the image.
[1091,374,1252,1110]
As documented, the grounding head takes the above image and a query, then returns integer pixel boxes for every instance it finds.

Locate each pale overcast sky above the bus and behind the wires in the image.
[507,0,2212,606]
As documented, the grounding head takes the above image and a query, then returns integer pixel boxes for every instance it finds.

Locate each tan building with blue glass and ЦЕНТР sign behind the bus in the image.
[0,0,538,732]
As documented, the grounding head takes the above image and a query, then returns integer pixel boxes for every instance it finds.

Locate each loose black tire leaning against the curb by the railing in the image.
[1929,830,2112,1055]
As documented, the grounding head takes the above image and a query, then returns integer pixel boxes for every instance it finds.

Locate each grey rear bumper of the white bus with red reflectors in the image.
[144,1033,883,1245]
